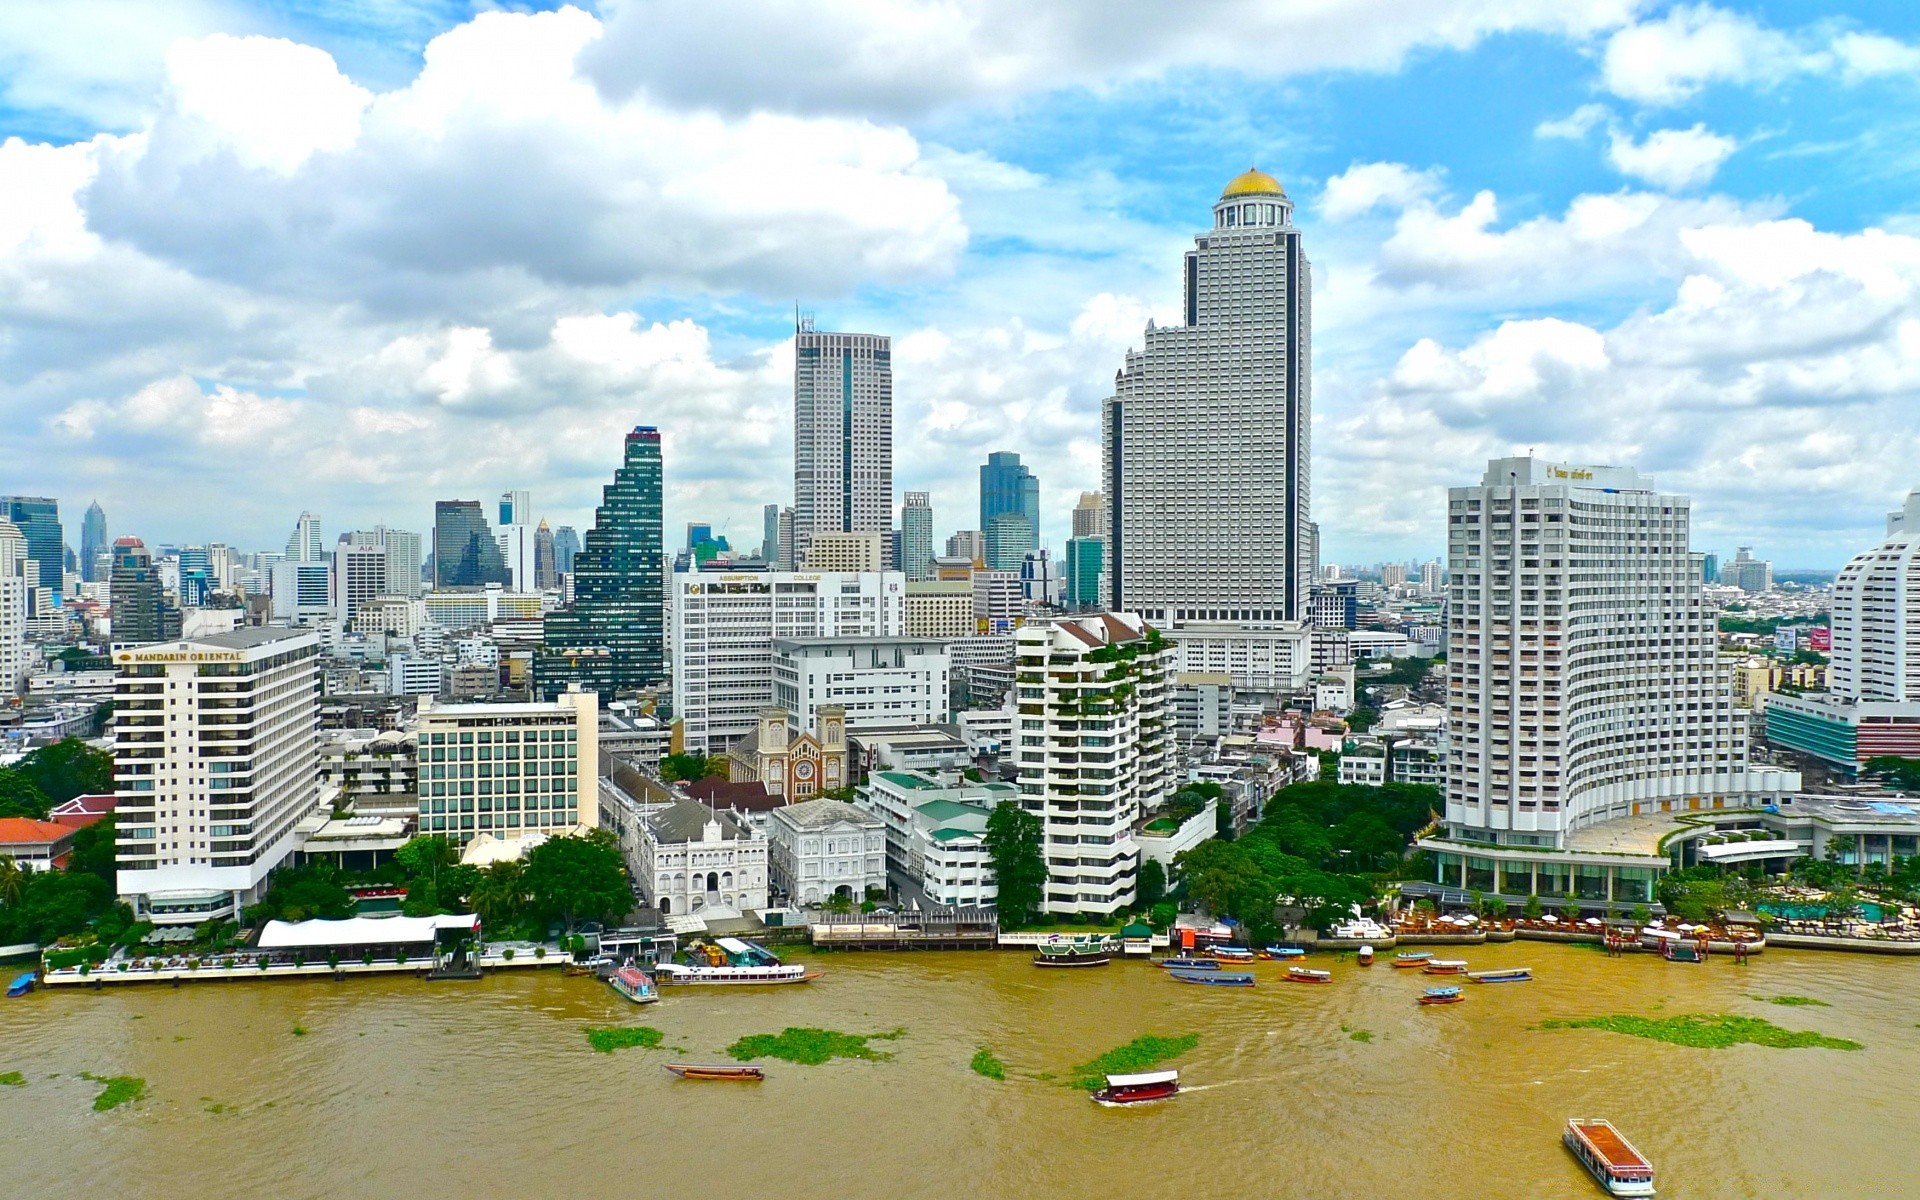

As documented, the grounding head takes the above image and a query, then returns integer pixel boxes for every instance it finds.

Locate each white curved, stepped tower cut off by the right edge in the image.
[1826,492,1920,703]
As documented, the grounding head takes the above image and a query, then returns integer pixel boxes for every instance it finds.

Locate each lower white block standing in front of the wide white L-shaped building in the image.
[774,637,950,733]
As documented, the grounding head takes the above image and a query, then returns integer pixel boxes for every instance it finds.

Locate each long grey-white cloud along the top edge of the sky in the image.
[588,0,1644,117]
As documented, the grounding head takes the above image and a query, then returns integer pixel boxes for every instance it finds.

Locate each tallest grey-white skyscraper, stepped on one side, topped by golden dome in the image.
[1100,171,1313,630]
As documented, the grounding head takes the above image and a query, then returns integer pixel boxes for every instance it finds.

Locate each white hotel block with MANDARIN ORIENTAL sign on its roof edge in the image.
[113,628,321,925]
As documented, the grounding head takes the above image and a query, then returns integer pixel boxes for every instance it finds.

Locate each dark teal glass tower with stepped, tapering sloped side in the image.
[534,424,666,703]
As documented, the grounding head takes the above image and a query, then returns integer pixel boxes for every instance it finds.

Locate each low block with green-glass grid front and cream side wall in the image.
[419,691,599,845]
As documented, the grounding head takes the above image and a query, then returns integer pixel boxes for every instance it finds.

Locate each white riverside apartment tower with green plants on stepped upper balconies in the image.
[1014,612,1173,912]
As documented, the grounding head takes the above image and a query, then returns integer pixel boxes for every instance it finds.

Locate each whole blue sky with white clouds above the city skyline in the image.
[0,0,1920,566]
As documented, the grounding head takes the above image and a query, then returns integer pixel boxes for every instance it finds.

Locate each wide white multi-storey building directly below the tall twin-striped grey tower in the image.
[668,570,906,755]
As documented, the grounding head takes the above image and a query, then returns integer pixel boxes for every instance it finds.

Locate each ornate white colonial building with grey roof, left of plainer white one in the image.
[636,801,768,918]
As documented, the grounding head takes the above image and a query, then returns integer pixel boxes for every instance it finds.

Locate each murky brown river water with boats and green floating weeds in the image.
[0,943,1920,1200]
